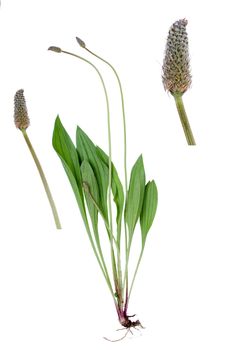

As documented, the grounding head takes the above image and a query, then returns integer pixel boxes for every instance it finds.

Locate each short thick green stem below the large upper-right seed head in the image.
[173,93,196,146]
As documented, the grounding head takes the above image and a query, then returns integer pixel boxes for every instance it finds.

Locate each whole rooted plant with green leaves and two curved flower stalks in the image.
[49,38,158,339]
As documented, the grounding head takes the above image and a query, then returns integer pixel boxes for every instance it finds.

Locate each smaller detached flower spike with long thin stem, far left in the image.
[14,89,61,229]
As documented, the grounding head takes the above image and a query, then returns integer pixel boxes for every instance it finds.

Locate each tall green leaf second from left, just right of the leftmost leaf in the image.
[76,127,109,222]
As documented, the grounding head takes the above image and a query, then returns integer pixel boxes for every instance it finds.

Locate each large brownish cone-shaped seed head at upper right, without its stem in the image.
[162,19,192,94]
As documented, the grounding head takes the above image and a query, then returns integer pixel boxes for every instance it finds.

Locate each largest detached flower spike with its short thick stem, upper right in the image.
[162,19,196,145]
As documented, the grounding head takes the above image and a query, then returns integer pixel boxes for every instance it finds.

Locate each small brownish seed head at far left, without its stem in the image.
[14,89,30,129]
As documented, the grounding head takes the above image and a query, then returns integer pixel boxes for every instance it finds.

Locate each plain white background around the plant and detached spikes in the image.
[0,0,232,350]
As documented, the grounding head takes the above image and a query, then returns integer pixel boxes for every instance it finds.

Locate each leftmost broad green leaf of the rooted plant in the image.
[52,117,87,225]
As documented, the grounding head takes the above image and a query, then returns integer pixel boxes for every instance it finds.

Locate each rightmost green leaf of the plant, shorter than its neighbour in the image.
[140,180,158,247]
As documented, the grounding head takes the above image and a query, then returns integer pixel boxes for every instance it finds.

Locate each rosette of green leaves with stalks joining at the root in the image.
[53,117,158,327]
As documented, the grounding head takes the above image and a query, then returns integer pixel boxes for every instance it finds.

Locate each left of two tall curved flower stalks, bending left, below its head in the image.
[61,50,118,284]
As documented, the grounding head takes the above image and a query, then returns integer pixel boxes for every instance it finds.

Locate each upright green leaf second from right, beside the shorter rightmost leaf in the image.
[125,155,145,240]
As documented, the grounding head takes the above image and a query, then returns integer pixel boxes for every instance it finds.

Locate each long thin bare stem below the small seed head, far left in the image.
[21,129,61,229]
